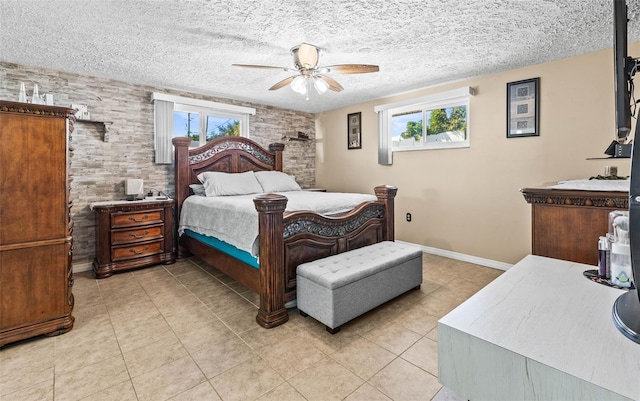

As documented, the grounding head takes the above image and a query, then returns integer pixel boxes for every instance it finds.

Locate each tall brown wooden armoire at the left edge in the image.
[0,101,74,347]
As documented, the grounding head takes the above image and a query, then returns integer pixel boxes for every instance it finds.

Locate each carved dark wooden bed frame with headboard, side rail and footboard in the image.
[173,137,397,328]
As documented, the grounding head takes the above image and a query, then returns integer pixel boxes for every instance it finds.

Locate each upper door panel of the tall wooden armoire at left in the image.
[0,115,67,244]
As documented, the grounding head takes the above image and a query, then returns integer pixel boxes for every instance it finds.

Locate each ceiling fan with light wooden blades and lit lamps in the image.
[232,43,380,99]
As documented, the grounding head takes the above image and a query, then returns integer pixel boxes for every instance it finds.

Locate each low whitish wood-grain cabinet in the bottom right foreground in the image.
[438,255,640,400]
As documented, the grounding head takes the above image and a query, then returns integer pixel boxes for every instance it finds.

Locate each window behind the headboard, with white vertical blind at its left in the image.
[151,93,256,164]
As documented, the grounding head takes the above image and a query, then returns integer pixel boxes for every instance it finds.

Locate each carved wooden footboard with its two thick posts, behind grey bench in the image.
[254,186,397,327]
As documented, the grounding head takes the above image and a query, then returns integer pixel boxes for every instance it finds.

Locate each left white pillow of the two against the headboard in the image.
[198,171,263,196]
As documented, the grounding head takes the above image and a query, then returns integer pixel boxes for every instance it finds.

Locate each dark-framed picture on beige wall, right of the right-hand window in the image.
[507,78,540,138]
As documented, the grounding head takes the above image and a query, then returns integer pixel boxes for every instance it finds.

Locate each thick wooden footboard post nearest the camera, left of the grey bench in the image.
[253,194,289,329]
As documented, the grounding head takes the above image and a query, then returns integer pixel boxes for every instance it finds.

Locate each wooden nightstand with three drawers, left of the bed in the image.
[91,199,176,278]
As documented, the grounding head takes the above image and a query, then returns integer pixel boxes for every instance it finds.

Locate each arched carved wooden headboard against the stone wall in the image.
[171,136,284,216]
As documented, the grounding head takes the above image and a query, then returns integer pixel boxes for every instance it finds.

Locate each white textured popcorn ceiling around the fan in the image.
[0,0,640,112]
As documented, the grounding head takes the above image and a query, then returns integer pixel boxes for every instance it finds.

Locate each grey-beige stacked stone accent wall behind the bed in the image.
[0,62,315,270]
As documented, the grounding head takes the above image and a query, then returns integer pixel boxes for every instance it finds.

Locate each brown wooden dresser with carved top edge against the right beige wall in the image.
[521,188,629,266]
